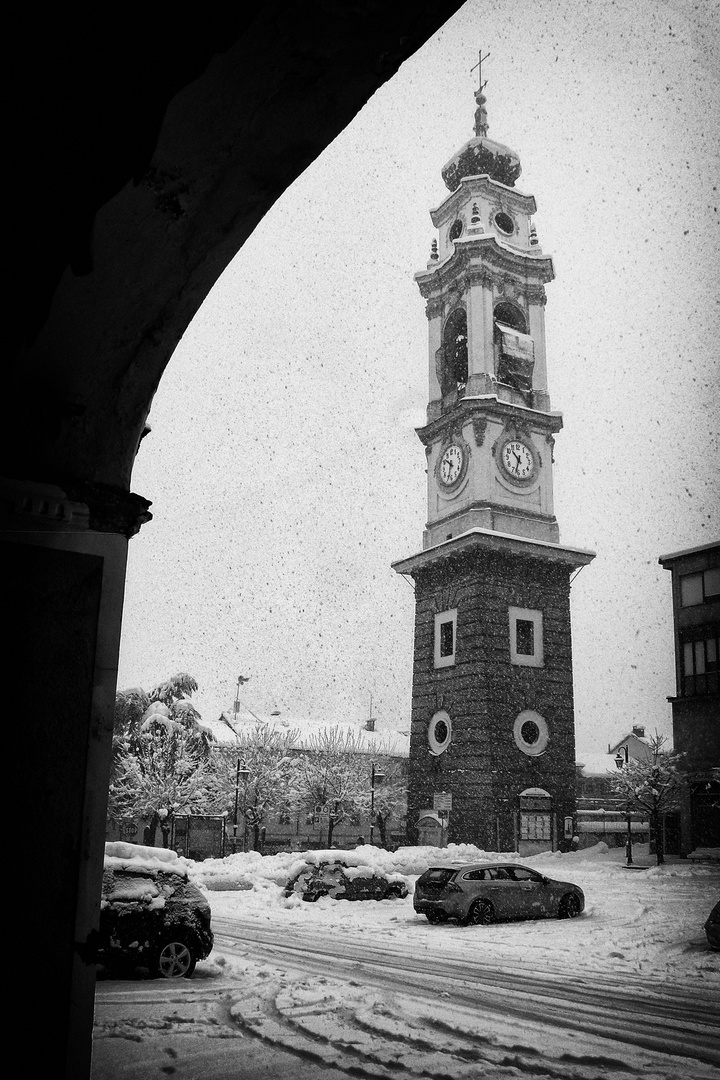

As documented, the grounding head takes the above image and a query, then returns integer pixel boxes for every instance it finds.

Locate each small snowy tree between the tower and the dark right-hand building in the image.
[611,731,685,865]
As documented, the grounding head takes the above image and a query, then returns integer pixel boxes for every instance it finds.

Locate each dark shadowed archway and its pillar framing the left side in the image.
[0,0,461,1080]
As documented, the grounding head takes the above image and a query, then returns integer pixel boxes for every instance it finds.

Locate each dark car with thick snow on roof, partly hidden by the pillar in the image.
[98,841,213,978]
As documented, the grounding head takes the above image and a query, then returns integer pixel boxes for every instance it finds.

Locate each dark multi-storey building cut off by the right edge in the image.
[658,542,720,855]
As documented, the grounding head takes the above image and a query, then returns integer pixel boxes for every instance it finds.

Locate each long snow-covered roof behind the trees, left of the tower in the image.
[201,711,410,757]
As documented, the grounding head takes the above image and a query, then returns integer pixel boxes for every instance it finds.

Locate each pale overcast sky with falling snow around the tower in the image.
[119,0,720,752]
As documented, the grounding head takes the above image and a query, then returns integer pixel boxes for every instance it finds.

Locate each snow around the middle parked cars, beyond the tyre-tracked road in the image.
[190,843,720,984]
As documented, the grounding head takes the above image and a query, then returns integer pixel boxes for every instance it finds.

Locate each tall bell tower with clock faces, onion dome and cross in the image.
[393,67,594,854]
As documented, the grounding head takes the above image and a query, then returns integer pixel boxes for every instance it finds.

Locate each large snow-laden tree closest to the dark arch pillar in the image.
[108,673,218,846]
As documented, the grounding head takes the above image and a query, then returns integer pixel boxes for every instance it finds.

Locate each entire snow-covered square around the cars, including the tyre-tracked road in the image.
[93,845,720,1080]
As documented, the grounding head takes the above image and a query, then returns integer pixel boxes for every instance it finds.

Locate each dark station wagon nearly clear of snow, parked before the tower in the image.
[412,863,585,924]
